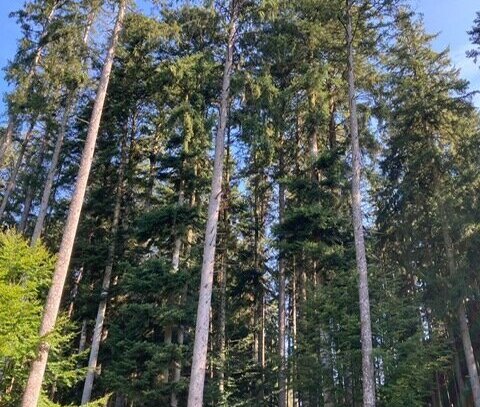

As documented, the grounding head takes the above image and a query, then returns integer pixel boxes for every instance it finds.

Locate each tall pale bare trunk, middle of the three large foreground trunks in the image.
[188,1,238,407]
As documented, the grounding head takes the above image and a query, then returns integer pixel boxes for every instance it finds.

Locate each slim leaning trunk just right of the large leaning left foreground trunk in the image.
[81,127,128,405]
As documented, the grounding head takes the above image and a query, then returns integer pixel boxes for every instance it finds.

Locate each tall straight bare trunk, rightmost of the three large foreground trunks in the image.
[346,0,375,407]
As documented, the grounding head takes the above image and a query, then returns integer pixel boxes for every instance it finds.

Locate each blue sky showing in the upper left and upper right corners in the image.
[0,0,480,121]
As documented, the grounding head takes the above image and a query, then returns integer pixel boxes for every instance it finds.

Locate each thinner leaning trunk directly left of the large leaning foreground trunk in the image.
[31,3,97,246]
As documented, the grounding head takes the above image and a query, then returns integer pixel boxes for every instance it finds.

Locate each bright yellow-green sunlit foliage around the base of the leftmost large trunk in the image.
[0,230,84,406]
